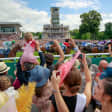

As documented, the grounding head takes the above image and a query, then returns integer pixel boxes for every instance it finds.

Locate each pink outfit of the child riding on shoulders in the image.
[21,40,37,64]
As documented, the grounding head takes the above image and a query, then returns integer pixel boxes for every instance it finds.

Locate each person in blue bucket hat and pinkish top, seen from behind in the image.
[29,65,52,112]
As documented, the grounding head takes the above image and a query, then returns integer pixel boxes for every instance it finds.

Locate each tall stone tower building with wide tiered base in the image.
[42,7,70,39]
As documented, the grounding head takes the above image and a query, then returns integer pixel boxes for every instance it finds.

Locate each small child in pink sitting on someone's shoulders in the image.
[20,32,39,70]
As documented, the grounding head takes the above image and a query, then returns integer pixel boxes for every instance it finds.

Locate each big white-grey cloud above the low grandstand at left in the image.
[0,0,50,32]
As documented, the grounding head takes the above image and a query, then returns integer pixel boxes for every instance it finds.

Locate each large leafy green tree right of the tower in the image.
[79,10,102,39]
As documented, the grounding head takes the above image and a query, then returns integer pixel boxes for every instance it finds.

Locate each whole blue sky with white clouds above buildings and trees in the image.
[0,0,112,32]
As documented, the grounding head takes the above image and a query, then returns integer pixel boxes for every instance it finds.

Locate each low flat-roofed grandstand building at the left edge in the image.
[0,22,22,40]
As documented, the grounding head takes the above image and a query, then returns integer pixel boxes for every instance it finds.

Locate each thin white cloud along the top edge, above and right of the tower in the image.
[52,0,100,9]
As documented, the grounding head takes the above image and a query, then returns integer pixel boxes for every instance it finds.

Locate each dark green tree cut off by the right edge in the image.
[105,22,112,39]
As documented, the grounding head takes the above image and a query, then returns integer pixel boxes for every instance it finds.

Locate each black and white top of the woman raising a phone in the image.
[50,94,86,112]
